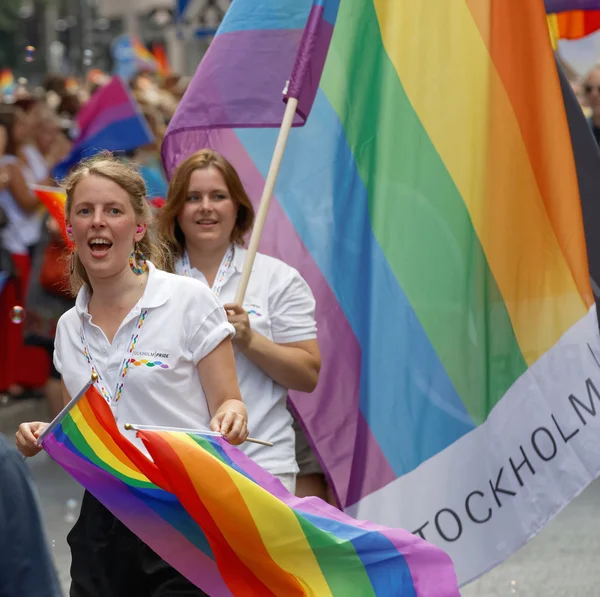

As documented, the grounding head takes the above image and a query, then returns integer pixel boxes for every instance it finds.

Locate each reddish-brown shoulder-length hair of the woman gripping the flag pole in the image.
[158,149,254,272]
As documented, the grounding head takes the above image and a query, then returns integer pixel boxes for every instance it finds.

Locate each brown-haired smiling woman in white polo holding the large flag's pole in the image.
[159,149,321,493]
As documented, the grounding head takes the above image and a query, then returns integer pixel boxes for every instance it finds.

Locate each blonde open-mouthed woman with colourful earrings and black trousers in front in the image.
[16,156,248,597]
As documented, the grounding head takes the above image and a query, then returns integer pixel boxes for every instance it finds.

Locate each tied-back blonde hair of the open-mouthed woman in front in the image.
[62,152,165,295]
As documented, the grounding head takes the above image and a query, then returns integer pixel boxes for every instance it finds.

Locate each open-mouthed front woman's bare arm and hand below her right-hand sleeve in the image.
[198,338,248,445]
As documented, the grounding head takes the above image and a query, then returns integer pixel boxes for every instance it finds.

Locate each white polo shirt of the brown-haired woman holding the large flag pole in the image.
[175,247,317,475]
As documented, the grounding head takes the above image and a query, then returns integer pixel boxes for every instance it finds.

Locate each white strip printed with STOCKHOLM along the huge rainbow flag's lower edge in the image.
[349,308,600,585]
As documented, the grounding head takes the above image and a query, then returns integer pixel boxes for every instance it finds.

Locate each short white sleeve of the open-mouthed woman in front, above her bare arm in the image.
[188,284,235,365]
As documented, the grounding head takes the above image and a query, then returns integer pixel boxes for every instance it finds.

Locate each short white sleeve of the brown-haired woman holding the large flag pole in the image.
[269,268,317,344]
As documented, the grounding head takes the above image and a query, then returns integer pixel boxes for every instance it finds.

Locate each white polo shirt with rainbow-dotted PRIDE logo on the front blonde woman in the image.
[54,262,234,447]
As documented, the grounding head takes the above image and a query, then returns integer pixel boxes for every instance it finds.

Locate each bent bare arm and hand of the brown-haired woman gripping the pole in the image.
[225,304,321,392]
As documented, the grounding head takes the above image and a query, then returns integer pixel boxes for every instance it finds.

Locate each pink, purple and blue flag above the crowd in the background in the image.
[53,76,154,179]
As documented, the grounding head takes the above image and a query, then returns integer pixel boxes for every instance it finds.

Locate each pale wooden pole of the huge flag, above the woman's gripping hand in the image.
[234,97,298,305]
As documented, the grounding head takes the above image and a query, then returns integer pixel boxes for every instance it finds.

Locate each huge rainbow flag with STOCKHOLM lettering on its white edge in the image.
[163,0,600,583]
